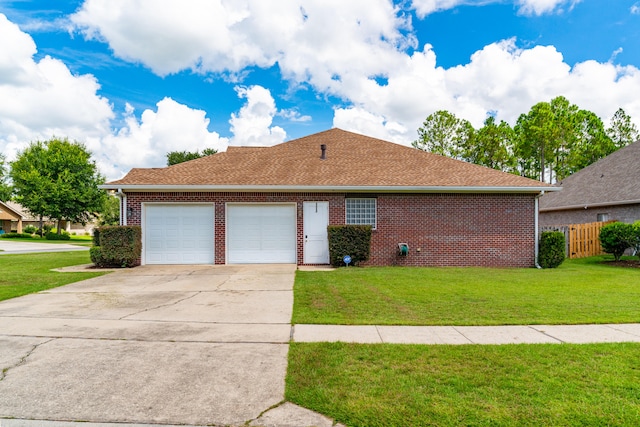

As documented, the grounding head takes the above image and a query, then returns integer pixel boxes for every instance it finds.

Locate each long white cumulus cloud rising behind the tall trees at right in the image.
[334,39,640,143]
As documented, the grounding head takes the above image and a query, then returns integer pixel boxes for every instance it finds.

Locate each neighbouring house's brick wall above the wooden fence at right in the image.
[540,204,640,227]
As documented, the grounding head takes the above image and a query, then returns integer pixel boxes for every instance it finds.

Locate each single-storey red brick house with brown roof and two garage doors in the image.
[102,129,558,267]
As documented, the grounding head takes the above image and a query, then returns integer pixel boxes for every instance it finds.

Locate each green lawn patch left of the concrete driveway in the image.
[0,251,105,301]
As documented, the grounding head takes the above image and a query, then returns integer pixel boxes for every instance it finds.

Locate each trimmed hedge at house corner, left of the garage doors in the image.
[89,226,142,267]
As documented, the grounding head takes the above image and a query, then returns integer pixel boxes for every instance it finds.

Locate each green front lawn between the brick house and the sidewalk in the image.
[293,257,640,325]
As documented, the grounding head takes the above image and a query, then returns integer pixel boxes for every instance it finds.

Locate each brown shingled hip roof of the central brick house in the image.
[103,129,557,192]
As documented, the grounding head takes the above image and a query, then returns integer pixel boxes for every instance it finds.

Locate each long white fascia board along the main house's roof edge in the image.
[99,184,562,193]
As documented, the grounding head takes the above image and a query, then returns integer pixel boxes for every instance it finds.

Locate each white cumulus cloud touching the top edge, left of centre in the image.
[70,0,415,82]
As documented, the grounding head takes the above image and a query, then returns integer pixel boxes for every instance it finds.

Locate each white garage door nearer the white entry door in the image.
[227,204,296,264]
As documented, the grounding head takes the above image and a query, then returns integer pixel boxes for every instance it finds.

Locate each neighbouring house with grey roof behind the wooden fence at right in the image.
[540,141,640,226]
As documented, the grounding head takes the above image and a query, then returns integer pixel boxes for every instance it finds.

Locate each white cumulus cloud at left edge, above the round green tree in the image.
[0,14,113,159]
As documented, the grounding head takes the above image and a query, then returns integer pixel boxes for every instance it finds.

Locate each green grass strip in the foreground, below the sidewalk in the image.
[286,343,640,427]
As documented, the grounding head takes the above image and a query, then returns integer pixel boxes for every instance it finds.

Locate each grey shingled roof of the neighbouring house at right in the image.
[540,141,640,212]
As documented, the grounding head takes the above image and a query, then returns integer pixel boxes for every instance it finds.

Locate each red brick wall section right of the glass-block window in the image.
[369,194,535,267]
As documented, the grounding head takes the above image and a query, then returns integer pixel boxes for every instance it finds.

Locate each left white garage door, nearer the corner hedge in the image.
[144,204,214,264]
